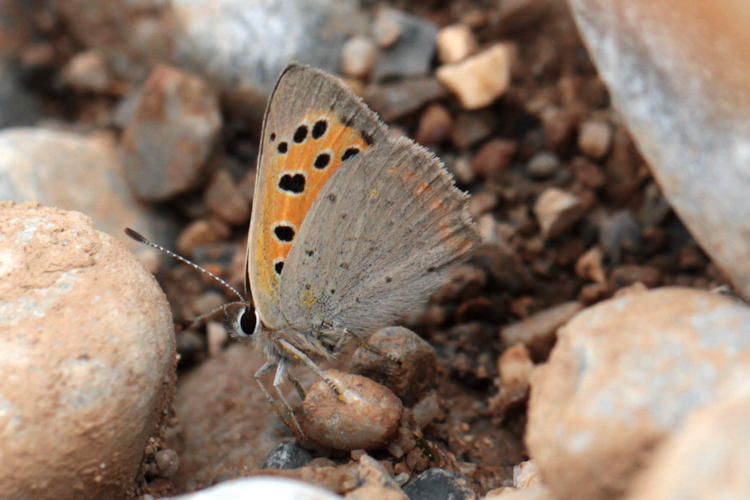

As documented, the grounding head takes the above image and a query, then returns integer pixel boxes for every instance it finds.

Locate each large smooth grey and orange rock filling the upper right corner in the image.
[570,0,750,298]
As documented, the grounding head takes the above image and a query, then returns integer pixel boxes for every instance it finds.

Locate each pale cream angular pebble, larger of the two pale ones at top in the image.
[436,43,514,109]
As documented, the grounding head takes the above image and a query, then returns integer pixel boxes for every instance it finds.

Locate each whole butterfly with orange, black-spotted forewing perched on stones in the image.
[129,64,479,436]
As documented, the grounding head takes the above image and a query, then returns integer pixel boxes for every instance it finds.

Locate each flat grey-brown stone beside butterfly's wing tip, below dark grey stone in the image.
[364,78,446,122]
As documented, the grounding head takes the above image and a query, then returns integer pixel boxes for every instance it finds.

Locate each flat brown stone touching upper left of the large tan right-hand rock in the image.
[500,301,581,359]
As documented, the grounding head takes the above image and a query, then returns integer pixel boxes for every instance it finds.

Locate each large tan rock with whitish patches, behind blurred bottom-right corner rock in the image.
[526,288,750,499]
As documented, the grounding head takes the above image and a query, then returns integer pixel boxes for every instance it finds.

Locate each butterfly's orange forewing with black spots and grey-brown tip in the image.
[246,64,386,328]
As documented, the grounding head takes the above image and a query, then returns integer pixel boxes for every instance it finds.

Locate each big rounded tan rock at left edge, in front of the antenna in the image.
[0,202,176,498]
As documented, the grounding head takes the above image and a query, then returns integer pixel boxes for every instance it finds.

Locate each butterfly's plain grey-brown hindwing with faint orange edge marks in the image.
[280,138,479,333]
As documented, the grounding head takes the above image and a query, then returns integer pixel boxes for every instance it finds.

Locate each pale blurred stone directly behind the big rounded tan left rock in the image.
[0,125,176,250]
